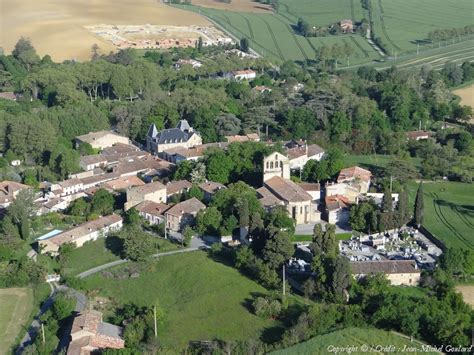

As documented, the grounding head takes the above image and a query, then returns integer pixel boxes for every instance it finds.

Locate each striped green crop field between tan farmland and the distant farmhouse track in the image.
[179,5,379,67]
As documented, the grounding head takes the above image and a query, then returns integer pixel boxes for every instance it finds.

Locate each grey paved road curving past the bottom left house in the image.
[15,282,87,354]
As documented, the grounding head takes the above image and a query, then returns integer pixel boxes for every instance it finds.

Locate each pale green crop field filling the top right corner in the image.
[371,0,474,54]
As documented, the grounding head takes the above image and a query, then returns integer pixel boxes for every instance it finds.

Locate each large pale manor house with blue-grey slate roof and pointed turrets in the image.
[146,120,202,153]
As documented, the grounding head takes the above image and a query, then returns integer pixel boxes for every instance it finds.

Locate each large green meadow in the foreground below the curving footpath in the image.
[79,251,281,351]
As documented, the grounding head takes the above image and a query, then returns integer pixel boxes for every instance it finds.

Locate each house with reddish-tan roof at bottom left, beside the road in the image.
[66,310,125,355]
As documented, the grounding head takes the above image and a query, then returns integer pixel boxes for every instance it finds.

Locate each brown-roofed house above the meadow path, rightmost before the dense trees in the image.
[165,197,206,232]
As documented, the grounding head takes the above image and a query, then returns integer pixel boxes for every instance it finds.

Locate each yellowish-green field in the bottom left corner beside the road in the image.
[0,288,33,354]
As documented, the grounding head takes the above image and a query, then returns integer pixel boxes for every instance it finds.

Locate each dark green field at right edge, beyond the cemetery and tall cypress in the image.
[408,182,474,249]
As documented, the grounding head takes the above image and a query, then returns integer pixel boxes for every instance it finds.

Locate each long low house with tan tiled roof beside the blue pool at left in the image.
[38,214,123,255]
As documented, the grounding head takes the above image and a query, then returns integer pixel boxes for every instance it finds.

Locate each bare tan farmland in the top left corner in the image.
[0,0,209,61]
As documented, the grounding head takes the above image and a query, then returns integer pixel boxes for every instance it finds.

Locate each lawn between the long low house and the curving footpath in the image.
[59,237,178,275]
